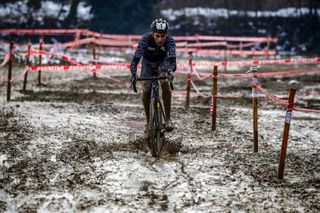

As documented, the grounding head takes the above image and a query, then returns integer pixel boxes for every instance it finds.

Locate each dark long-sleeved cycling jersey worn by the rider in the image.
[130,32,176,74]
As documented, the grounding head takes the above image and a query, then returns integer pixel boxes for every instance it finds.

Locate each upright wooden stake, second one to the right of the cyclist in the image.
[211,66,218,131]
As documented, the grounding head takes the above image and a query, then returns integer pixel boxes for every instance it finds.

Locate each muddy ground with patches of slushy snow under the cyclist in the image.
[0,64,320,212]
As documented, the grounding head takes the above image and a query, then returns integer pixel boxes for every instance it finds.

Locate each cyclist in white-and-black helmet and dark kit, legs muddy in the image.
[130,18,176,139]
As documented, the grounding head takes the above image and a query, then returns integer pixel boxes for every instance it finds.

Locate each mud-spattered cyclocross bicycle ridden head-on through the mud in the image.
[137,76,173,157]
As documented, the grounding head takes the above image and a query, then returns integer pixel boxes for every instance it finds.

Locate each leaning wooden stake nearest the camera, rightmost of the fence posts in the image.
[278,88,296,179]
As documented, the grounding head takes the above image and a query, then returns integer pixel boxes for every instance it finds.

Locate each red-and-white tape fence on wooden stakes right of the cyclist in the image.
[182,54,320,179]
